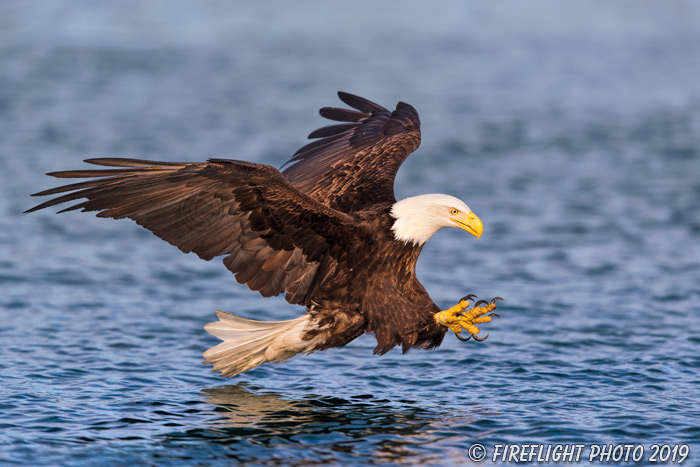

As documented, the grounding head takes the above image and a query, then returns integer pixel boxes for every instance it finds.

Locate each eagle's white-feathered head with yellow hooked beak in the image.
[391,194,484,245]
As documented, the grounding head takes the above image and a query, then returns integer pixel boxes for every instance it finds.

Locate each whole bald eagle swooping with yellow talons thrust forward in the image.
[26,92,498,376]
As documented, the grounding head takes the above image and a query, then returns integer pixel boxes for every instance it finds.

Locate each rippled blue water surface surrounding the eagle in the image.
[0,0,700,466]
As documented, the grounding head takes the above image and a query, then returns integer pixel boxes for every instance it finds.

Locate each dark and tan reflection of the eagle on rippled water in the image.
[191,384,493,463]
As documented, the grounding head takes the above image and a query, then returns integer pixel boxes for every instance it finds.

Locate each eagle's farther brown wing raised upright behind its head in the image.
[283,92,420,212]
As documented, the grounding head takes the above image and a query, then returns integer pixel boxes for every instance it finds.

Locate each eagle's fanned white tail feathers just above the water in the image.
[203,311,315,376]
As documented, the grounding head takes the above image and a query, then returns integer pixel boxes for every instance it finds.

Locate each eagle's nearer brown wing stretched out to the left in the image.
[27,159,355,304]
